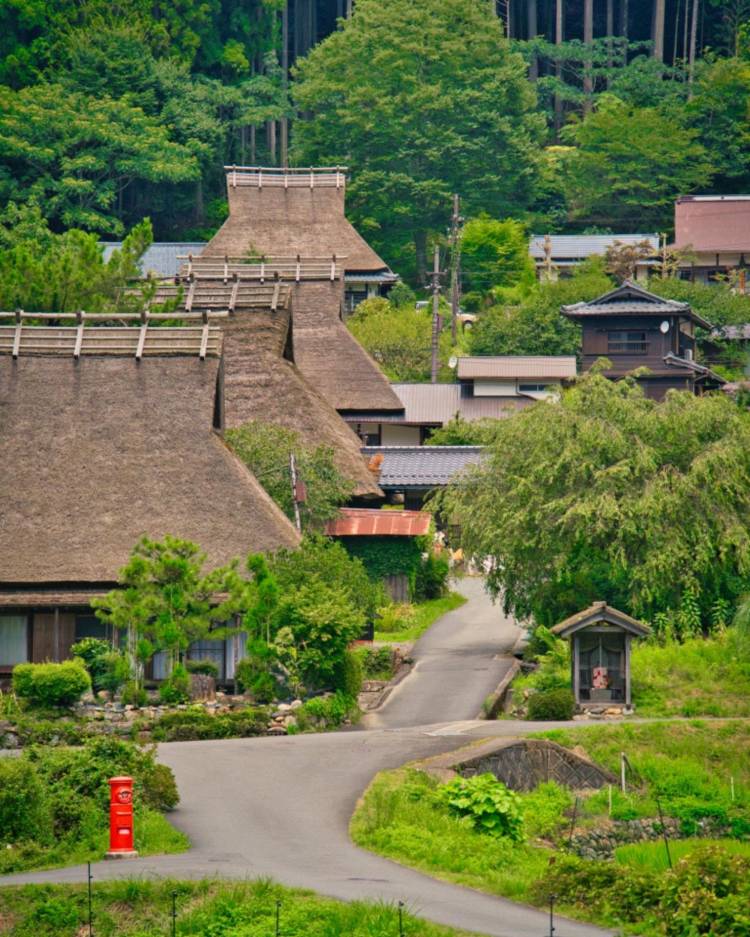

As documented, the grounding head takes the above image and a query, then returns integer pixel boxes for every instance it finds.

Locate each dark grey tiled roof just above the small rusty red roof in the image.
[362,446,484,490]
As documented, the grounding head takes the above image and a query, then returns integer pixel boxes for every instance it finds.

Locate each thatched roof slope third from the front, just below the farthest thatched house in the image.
[292,280,404,412]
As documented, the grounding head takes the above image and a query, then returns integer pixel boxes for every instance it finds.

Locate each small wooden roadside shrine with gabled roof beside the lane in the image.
[552,602,651,709]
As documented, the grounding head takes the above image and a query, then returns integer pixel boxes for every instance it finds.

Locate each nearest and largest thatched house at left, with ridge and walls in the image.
[0,314,299,679]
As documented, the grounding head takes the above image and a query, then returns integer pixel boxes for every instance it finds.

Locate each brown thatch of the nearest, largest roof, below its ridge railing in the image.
[0,354,298,588]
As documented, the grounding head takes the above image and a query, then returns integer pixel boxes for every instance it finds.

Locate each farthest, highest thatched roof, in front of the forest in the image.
[209,170,388,272]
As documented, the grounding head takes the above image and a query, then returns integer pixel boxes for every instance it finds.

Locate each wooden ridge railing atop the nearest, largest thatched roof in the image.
[0,309,227,361]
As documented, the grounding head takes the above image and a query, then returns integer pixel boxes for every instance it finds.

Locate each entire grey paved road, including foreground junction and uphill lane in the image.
[0,580,610,937]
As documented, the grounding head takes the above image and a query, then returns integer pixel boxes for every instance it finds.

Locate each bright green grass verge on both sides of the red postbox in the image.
[0,808,190,876]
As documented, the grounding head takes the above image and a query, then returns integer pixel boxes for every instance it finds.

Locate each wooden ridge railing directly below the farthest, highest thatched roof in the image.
[177,254,346,283]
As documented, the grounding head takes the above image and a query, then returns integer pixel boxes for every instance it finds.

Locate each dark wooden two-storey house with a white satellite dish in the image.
[562,280,724,400]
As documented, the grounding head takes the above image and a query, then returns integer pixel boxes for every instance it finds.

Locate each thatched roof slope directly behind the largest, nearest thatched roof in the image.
[217,308,382,496]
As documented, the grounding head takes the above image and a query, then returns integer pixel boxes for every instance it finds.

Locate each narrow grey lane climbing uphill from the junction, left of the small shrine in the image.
[363,577,520,729]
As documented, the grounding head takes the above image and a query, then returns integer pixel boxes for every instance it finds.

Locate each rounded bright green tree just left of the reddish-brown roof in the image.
[563,95,713,231]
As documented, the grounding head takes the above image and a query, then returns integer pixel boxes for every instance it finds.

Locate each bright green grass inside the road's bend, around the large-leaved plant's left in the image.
[350,768,552,901]
